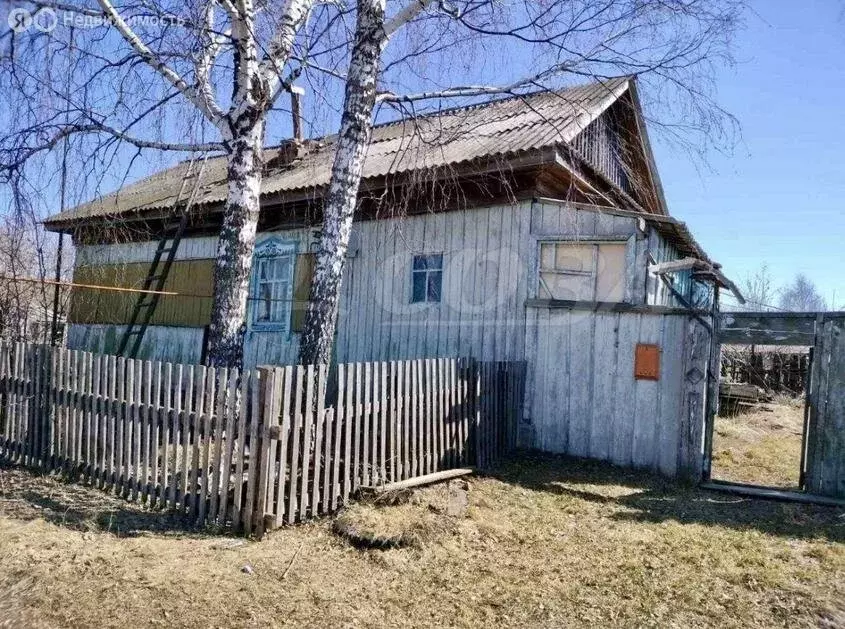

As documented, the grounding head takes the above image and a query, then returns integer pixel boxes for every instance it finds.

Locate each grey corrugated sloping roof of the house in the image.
[46,77,629,227]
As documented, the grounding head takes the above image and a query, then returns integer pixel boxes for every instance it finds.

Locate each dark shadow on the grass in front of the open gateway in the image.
[489,452,845,543]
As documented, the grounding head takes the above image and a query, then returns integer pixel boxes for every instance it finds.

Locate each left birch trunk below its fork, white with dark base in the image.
[207,116,264,367]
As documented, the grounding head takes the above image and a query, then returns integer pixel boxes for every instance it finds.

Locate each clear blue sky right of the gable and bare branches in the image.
[652,0,845,309]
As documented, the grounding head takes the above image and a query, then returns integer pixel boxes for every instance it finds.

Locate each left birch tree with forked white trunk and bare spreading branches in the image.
[0,0,320,365]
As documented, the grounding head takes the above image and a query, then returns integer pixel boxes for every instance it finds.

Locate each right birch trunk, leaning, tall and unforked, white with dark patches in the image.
[299,0,386,364]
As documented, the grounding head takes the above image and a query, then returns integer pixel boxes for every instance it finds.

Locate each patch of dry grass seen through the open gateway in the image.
[712,398,804,488]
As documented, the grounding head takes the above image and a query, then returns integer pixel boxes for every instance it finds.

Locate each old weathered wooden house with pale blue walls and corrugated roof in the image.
[47,78,740,474]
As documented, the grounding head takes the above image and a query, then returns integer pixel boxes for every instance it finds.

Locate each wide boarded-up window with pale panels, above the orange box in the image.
[537,242,626,302]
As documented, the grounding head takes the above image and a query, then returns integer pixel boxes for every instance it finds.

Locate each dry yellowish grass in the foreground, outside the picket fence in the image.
[0,457,845,627]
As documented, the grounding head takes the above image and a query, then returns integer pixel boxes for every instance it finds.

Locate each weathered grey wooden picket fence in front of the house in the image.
[0,344,524,534]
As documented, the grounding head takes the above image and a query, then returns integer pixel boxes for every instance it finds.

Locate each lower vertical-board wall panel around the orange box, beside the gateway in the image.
[523,308,709,477]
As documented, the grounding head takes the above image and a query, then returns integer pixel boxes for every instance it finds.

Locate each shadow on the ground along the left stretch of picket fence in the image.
[0,463,214,537]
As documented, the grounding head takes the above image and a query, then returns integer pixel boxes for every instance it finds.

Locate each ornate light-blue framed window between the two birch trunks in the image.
[250,239,296,331]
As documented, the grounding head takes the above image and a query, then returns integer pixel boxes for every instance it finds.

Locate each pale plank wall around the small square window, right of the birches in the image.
[330,204,529,360]
